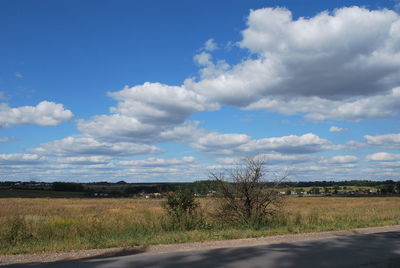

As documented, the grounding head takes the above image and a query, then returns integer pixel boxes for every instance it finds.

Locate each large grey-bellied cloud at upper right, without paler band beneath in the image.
[187,7,400,106]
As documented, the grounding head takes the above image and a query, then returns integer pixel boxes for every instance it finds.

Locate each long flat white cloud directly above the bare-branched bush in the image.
[192,133,333,155]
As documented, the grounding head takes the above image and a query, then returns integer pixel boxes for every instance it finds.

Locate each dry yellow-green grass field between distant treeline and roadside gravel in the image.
[0,197,400,254]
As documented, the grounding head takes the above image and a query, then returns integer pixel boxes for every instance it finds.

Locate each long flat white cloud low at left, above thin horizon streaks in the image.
[29,136,161,157]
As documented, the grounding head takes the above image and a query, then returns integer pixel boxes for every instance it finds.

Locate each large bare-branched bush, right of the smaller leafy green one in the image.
[210,158,287,225]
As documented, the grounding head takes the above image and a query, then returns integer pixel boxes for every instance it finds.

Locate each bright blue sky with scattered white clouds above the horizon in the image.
[0,0,400,182]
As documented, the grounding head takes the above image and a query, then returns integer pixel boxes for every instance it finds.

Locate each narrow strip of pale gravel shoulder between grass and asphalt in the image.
[0,225,400,266]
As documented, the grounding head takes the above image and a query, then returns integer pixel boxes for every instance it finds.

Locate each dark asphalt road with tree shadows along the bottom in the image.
[4,231,400,268]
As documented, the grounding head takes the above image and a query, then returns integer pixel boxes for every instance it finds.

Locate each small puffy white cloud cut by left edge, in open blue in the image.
[0,101,73,128]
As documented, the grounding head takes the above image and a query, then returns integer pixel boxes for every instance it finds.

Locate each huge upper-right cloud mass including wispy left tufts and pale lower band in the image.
[185,7,400,121]
